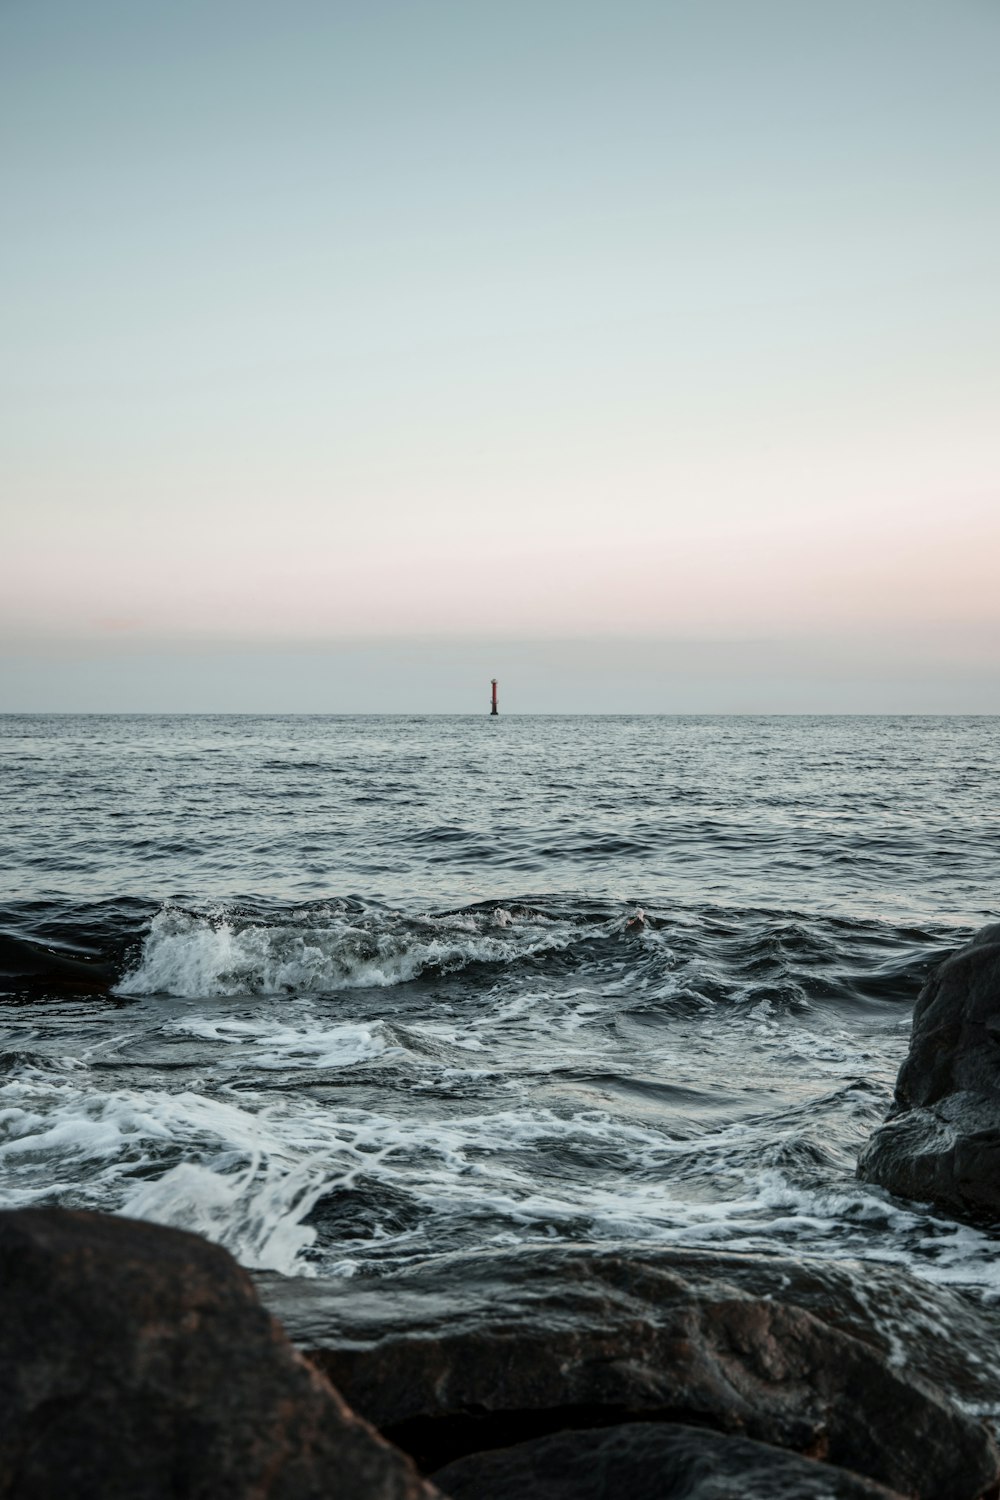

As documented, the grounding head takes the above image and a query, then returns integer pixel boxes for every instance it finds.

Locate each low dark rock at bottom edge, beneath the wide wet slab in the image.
[433,1422,900,1500]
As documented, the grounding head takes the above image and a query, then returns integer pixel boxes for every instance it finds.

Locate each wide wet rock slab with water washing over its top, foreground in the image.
[261,1247,1000,1500]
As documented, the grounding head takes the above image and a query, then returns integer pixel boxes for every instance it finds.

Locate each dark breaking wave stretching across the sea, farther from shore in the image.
[0,894,961,1011]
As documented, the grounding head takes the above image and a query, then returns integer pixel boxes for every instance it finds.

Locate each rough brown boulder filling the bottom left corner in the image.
[0,1209,438,1500]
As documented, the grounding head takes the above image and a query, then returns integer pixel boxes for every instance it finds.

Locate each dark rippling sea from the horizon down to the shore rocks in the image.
[0,716,1000,1293]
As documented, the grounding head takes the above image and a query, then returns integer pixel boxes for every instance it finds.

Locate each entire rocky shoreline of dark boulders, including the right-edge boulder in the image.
[0,927,1000,1500]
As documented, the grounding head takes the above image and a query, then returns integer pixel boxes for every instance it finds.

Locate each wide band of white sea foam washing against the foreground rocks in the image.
[0,1056,1000,1296]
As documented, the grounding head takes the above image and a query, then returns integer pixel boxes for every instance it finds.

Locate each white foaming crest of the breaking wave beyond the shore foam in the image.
[117,908,574,998]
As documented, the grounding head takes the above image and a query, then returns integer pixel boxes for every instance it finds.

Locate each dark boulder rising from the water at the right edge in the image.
[858,926,1000,1224]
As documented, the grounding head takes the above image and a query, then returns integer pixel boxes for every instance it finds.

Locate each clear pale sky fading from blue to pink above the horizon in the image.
[0,0,1000,713]
